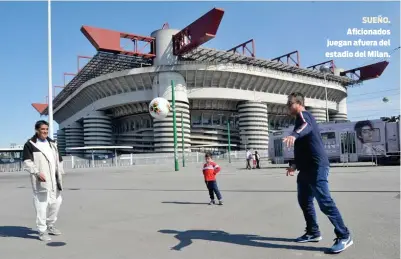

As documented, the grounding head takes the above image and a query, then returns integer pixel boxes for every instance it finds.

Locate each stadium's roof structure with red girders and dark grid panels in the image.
[36,8,389,115]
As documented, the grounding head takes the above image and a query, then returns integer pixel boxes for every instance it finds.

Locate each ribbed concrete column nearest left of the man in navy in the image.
[238,101,269,151]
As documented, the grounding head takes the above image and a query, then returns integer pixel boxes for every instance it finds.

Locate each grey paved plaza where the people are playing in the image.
[0,162,400,259]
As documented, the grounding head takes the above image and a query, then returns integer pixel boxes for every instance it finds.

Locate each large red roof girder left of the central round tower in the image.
[81,26,156,58]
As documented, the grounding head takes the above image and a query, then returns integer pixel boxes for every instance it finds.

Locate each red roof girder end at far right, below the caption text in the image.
[340,61,389,81]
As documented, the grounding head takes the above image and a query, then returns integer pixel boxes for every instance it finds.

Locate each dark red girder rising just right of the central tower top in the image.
[173,8,224,55]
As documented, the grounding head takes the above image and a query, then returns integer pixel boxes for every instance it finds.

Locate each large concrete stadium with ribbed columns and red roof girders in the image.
[32,8,388,156]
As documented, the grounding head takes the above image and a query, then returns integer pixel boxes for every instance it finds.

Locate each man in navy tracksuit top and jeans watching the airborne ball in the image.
[283,93,353,253]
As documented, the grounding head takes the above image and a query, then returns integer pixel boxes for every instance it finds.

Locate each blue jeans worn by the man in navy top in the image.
[297,167,350,238]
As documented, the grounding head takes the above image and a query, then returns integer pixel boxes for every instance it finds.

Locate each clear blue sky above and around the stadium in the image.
[0,1,400,147]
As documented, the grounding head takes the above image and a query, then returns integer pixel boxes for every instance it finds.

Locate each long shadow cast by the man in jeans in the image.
[159,229,327,252]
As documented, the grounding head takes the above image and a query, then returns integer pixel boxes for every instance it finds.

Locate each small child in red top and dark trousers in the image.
[203,153,223,205]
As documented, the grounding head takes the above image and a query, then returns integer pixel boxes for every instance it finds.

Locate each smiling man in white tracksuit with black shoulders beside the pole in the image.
[23,120,63,241]
